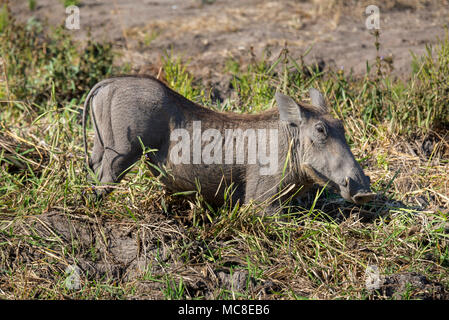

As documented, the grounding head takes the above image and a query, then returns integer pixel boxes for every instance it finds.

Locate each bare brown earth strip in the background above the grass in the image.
[12,0,449,82]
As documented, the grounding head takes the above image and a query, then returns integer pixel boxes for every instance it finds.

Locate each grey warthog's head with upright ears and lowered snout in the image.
[275,89,375,204]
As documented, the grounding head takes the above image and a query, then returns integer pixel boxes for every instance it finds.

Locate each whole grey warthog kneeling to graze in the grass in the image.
[83,76,374,211]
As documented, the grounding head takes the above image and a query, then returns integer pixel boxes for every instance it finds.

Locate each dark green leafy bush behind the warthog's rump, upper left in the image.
[0,13,114,106]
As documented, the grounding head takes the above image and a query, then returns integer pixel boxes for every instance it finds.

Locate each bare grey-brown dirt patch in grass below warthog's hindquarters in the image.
[28,212,185,281]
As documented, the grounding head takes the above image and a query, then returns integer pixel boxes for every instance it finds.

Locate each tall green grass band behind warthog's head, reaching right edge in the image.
[223,31,449,136]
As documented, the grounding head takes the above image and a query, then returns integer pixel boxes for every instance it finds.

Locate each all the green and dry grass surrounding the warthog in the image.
[0,9,449,299]
